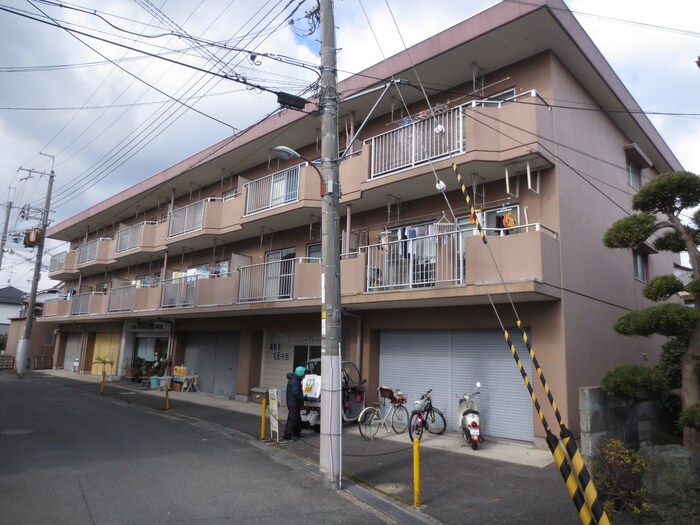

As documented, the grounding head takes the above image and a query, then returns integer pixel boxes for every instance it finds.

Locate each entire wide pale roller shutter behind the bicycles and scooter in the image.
[379,330,534,442]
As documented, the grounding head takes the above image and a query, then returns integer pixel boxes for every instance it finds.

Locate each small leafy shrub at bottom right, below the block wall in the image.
[592,439,652,516]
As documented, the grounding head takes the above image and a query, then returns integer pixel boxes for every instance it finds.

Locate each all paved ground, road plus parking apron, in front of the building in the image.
[0,371,581,525]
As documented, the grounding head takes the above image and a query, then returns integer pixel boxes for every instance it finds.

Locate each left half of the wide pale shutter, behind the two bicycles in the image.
[379,330,456,417]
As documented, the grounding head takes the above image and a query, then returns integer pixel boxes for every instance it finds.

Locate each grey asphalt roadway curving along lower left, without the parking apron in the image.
[0,373,402,525]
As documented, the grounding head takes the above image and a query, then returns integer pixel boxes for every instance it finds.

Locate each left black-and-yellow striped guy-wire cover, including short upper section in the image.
[452,163,595,525]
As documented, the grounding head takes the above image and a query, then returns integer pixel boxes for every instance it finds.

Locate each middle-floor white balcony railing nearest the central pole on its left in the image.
[238,259,295,303]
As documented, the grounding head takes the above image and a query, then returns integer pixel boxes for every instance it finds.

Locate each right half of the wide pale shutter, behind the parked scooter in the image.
[449,330,533,442]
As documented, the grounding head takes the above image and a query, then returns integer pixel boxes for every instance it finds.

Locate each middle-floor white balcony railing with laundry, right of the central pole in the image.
[360,231,464,292]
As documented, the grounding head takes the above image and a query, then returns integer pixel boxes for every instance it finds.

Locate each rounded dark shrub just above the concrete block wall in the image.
[600,364,667,401]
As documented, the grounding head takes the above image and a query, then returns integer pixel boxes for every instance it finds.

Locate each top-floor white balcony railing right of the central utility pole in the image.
[365,107,464,178]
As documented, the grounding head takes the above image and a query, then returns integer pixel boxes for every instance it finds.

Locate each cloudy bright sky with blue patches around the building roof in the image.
[0,0,700,290]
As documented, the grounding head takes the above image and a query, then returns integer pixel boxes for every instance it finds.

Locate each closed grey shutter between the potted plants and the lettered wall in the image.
[185,332,239,398]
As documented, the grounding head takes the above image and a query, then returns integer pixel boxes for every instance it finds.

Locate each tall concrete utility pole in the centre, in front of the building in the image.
[319,0,343,490]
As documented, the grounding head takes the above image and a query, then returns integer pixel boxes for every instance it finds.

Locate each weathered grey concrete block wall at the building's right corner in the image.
[579,387,658,458]
